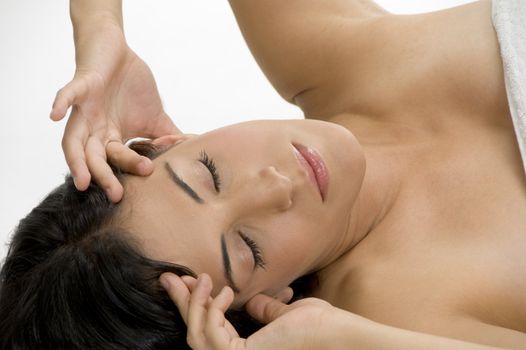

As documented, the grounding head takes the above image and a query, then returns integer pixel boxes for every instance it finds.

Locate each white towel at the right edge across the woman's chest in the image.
[492,0,526,175]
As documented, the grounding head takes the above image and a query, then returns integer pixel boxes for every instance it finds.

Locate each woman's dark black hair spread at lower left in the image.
[0,142,318,350]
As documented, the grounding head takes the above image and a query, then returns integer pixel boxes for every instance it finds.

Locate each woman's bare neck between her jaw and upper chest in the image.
[330,115,429,256]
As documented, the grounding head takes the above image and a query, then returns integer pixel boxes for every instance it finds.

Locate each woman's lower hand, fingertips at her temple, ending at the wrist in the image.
[161,274,337,350]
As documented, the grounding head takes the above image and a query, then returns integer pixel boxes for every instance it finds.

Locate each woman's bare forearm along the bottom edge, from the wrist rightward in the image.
[330,311,508,350]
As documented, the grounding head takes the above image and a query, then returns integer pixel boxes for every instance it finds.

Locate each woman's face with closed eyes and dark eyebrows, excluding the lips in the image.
[122,120,365,305]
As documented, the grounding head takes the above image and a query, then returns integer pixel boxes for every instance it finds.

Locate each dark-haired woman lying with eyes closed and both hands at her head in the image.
[0,0,526,349]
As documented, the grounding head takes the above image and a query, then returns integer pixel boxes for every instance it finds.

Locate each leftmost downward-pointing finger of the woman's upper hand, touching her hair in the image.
[62,108,91,191]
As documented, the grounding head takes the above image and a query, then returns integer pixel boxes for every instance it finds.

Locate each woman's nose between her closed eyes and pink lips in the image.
[240,166,292,212]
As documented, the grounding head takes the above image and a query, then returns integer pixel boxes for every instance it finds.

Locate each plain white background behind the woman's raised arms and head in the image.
[0,0,478,260]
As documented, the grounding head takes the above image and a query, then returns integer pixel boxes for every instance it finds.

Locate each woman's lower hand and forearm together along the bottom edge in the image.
[160,273,508,350]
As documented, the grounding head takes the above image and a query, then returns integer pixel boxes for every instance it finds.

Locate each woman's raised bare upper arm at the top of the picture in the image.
[230,0,384,102]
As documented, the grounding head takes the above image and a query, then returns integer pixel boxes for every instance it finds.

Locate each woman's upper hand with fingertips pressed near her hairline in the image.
[51,23,180,202]
